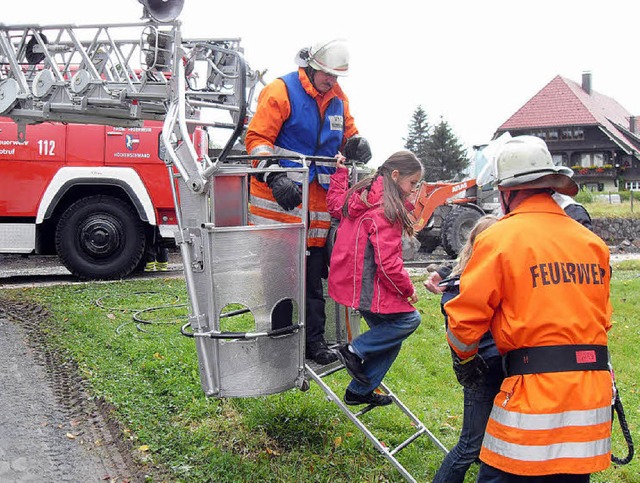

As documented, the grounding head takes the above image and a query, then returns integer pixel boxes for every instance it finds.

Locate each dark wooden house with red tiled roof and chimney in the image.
[494,72,640,192]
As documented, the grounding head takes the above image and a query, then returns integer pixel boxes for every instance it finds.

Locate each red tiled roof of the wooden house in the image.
[498,75,640,152]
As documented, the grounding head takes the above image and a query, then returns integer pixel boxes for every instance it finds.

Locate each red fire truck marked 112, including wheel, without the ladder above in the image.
[0,118,206,279]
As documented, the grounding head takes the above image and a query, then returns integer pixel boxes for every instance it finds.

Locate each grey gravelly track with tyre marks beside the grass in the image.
[0,304,143,483]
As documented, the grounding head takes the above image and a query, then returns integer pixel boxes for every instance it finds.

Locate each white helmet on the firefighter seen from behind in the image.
[494,136,578,196]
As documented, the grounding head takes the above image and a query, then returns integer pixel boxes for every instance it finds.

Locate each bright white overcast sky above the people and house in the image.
[1,0,640,164]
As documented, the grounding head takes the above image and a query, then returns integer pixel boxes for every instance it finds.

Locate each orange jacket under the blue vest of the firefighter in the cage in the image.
[245,69,358,247]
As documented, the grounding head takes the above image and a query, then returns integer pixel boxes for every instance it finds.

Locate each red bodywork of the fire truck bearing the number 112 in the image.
[0,118,175,223]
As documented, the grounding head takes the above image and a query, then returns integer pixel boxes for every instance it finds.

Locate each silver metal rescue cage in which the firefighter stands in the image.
[179,164,308,397]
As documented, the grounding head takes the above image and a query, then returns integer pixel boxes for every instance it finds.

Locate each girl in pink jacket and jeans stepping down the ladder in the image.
[327,151,422,406]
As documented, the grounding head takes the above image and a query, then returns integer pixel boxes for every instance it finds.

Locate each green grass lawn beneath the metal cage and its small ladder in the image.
[0,262,640,482]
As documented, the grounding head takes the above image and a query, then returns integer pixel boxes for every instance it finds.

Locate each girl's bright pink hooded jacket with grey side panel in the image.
[327,169,415,314]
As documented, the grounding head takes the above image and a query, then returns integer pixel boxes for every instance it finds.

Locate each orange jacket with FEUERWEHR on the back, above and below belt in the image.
[445,194,613,476]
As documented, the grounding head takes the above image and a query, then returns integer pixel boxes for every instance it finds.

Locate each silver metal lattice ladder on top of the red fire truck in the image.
[0,18,261,159]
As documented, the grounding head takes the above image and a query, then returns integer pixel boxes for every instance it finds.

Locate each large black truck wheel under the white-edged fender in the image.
[56,195,146,279]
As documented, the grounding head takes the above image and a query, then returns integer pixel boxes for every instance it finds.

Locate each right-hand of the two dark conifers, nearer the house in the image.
[425,117,469,181]
